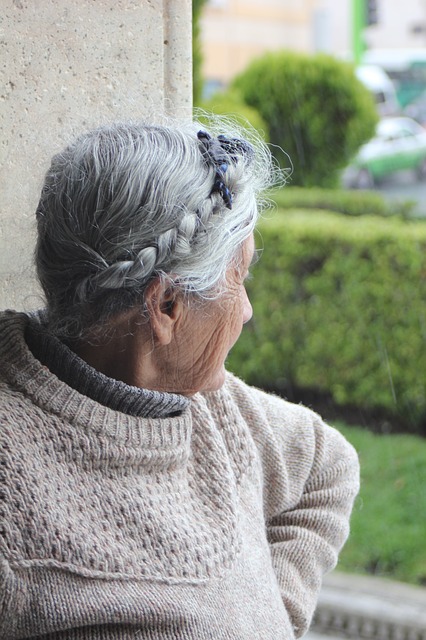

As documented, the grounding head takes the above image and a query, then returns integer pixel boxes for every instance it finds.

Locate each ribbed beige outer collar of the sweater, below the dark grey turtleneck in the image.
[0,311,191,456]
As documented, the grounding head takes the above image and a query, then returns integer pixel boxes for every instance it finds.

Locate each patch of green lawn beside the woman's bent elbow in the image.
[336,424,426,585]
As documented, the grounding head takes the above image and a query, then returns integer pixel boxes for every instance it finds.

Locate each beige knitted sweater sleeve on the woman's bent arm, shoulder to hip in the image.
[223,372,359,637]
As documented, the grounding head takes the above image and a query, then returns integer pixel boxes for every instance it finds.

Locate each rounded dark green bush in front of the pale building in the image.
[233,51,377,187]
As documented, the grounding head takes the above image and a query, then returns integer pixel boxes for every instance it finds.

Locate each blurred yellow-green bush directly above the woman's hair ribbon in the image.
[195,90,268,140]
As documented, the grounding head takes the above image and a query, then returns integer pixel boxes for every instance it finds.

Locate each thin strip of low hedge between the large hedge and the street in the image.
[270,187,415,218]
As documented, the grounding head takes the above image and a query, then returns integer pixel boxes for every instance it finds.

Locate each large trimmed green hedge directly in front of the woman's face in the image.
[228,211,426,431]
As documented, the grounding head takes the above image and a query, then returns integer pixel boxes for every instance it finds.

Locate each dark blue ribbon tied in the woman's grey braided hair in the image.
[197,131,253,209]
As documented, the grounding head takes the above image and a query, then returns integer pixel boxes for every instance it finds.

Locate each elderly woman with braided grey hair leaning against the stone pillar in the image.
[0,119,358,640]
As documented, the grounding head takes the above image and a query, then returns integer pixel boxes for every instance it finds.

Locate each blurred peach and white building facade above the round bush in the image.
[201,0,426,88]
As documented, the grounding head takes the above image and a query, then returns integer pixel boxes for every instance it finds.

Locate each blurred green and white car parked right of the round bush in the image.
[343,117,426,189]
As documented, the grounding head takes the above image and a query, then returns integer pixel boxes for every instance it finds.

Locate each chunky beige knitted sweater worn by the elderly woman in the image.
[0,312,358,640]
